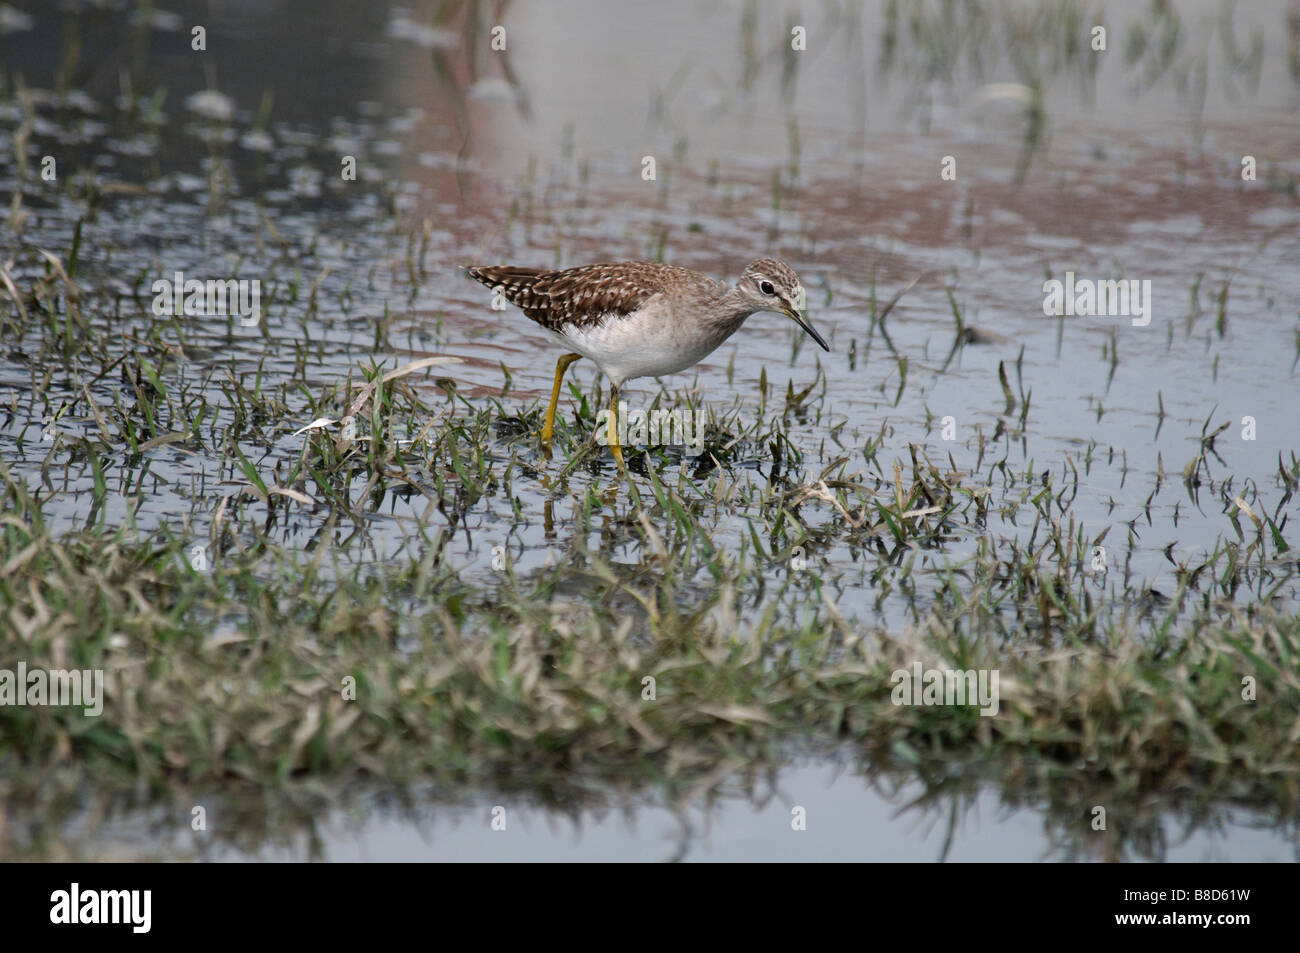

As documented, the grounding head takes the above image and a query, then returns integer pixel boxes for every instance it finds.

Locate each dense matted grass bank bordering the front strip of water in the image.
[0,457,1300,854]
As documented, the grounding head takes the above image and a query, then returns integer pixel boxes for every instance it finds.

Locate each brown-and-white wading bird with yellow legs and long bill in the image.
[468,259,831,467]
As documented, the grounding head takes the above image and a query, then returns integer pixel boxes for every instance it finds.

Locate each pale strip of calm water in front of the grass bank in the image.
[30,761,1300,863]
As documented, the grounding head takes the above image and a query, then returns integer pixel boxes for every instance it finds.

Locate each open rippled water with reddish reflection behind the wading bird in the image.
[0,0,1300,857]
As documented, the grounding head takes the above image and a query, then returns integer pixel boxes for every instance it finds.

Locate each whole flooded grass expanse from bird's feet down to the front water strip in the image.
[0,204,1300,857]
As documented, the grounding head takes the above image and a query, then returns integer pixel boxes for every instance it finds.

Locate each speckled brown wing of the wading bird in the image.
[468,261,701,333]
